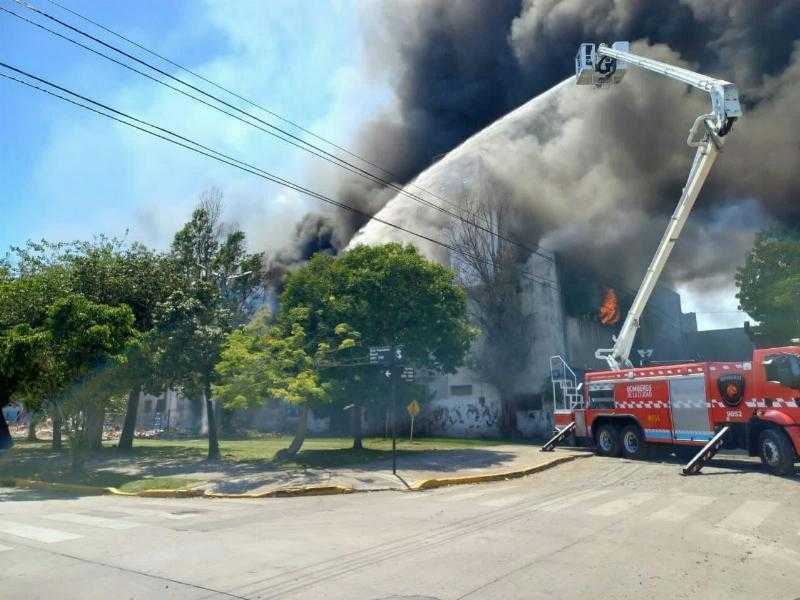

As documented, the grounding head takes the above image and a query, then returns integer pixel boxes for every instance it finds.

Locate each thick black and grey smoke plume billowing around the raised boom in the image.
[330,0,800,300]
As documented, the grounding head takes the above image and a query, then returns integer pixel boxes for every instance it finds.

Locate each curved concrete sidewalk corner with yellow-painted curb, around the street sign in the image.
[198,444,587,494]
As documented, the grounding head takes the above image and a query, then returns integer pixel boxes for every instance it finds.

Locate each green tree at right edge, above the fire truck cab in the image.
[736,229,800,347]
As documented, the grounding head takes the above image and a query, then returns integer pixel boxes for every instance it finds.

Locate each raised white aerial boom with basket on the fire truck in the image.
[575,42,742,370]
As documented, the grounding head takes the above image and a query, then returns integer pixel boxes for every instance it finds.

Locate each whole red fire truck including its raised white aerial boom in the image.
[543,42,800,475]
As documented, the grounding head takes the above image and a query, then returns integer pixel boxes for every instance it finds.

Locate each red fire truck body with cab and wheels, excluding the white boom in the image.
[553,346,800,475]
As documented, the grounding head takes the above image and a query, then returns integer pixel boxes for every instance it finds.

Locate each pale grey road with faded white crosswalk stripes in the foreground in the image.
[0,457,800,600]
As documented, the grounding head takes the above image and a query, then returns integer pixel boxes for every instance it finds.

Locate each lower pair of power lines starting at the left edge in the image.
[0,62,560,290]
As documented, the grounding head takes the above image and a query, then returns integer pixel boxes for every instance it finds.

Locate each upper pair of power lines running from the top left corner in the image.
[6,0,552,260]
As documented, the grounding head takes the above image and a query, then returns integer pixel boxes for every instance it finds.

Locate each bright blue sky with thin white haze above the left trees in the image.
[0,0,389,248]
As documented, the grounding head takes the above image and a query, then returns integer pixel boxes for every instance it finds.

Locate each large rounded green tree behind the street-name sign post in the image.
[281,244,476,448]
